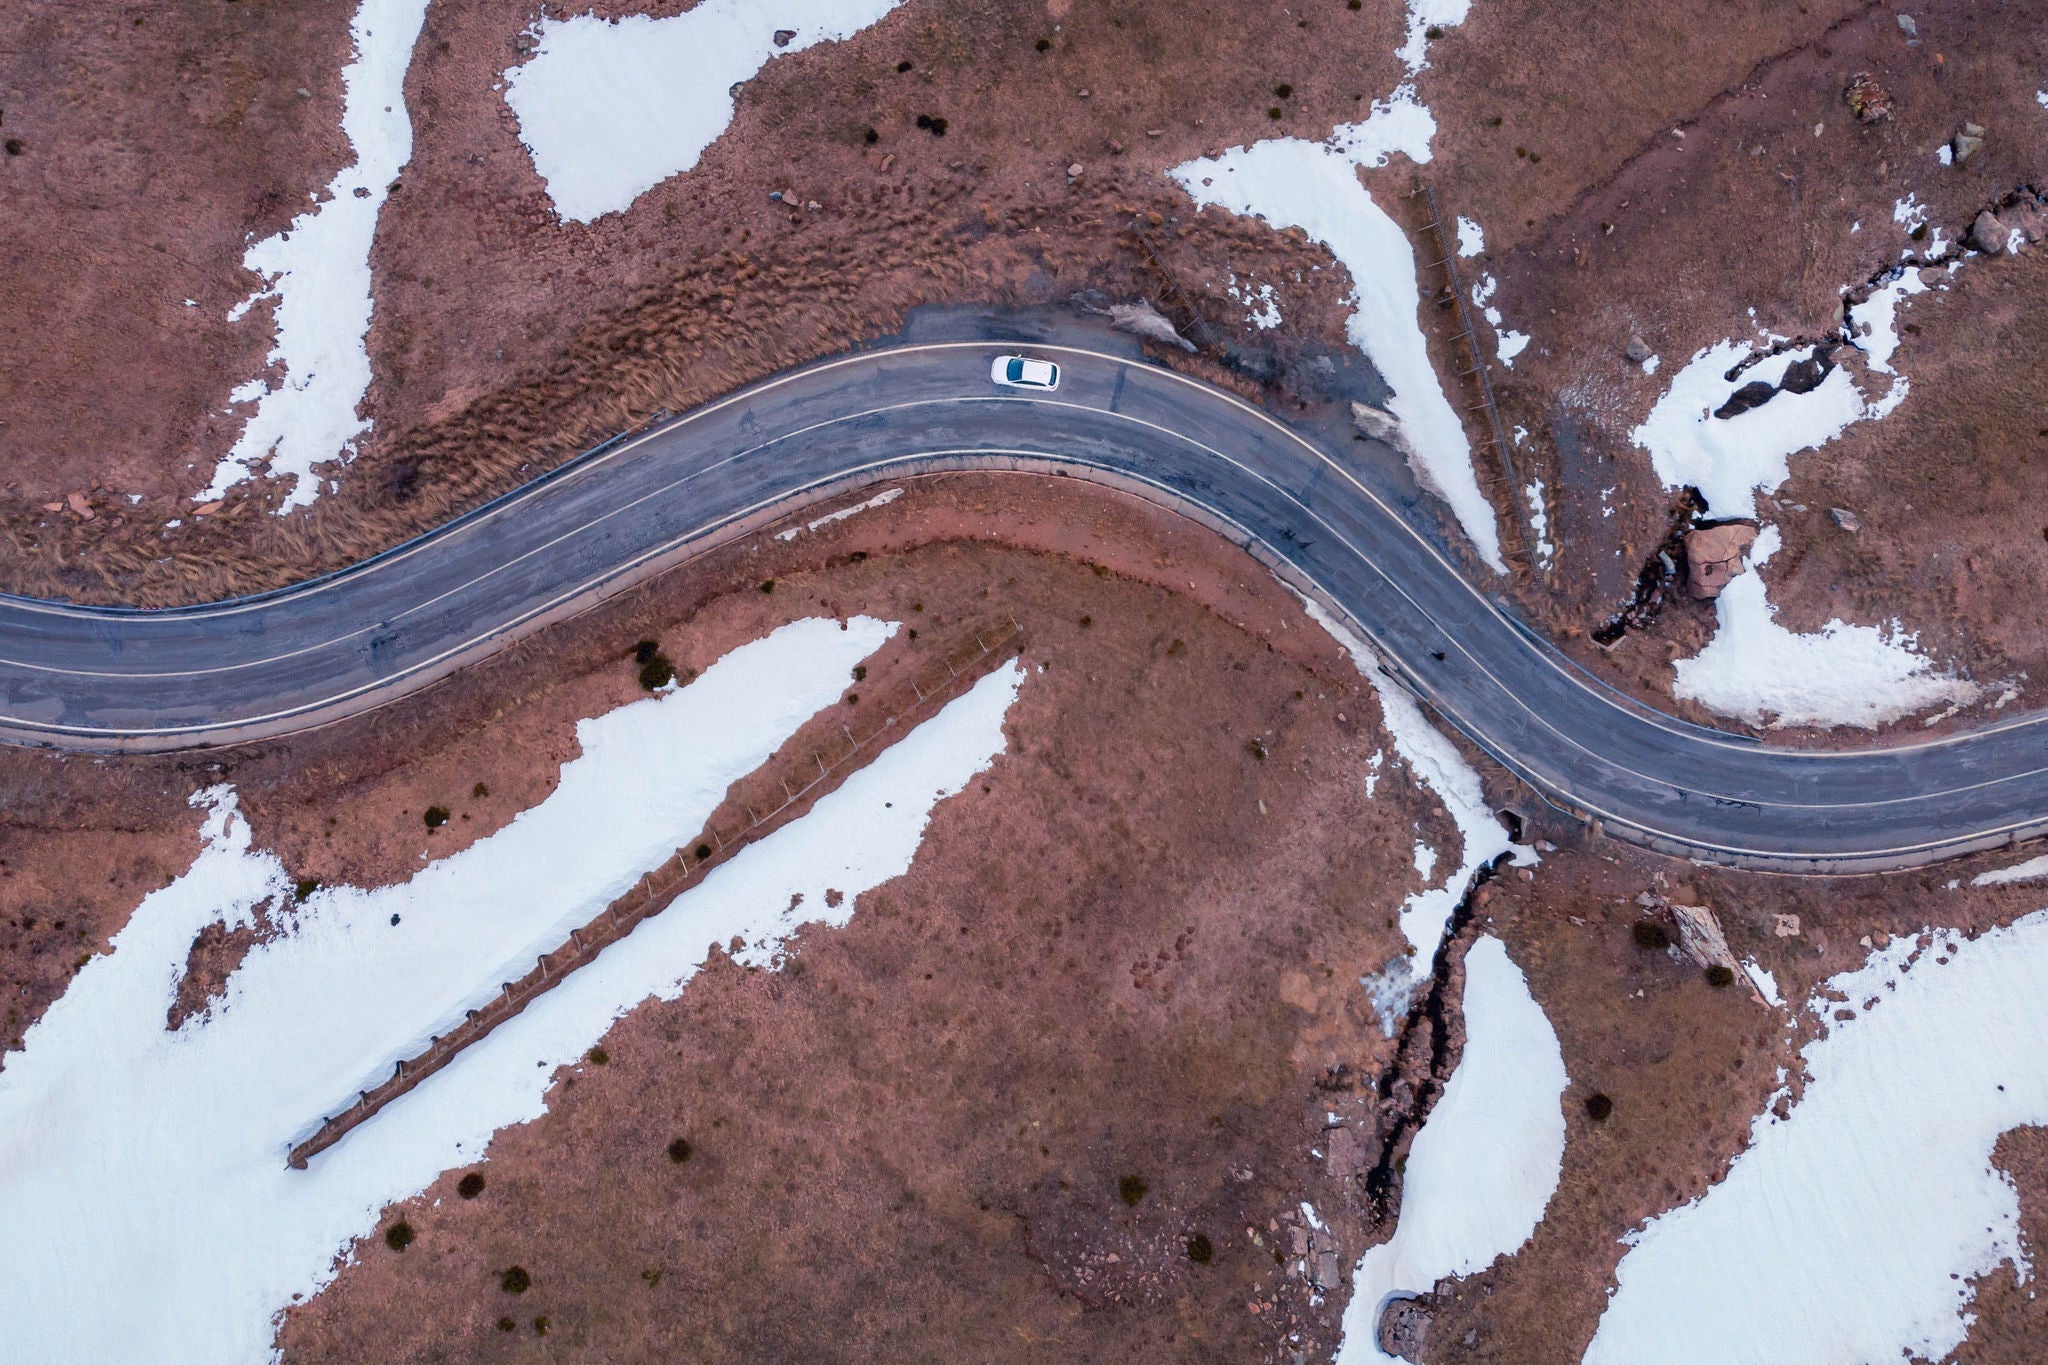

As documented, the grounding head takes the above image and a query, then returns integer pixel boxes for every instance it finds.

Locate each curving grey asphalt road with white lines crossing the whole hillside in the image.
[0,325,2048,872]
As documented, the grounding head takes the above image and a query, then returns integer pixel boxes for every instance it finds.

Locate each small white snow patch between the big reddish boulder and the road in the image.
[1671,527,1982,729]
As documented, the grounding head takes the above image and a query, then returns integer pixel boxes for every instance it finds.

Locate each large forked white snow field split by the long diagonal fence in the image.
[0,618,1022,1365]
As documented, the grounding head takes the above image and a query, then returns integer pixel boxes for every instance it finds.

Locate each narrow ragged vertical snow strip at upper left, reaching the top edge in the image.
[205,0,426,514]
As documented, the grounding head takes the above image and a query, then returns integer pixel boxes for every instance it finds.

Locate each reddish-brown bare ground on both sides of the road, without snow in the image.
[12,0,2048,1363]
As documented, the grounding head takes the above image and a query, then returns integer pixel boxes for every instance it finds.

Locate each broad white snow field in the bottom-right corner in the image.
[1585,911,2048,1365]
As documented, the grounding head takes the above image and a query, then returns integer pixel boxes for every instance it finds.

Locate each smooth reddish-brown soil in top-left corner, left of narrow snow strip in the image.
[0,0,354,507]
